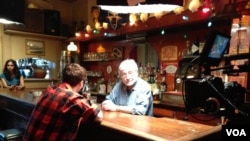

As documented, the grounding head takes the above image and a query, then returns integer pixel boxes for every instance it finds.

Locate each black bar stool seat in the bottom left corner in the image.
[0,128,24,141]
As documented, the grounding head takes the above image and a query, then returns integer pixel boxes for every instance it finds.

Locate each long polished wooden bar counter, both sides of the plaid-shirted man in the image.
[0,89,221,141]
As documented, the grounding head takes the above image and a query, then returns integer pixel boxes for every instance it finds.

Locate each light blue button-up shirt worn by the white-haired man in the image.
[106,78,153,116]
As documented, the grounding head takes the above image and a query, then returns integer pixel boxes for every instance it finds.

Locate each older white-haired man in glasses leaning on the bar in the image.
[102,59,153,116]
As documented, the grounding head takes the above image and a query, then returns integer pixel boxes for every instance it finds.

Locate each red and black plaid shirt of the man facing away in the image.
[23,83,96,141]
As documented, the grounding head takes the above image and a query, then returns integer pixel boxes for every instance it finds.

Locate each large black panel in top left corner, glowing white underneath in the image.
[0,0,25,23]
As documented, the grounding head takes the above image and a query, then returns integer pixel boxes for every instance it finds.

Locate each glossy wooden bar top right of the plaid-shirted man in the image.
[101,111,221,141]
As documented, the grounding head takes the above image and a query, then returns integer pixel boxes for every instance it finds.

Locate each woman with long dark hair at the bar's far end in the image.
[0,59,25,90]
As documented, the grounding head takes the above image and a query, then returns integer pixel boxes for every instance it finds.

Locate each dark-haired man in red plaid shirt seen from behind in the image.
[23,63,102,141]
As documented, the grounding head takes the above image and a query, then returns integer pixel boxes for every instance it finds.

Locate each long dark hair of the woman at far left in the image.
[3,59,21,80]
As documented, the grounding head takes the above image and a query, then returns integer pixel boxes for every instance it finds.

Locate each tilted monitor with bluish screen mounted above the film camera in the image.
[199,31,231,67]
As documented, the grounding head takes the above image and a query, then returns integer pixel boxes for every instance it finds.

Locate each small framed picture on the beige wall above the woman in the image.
[25,39,45,56]
